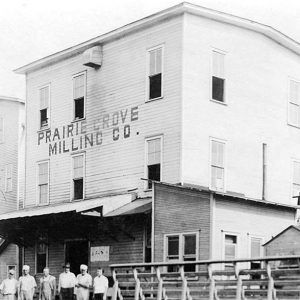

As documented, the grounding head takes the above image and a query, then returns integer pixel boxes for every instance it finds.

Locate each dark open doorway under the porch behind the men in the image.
[65,241,89,275]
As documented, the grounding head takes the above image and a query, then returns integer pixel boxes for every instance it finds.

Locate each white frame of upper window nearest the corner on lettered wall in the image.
[145,44,165,102]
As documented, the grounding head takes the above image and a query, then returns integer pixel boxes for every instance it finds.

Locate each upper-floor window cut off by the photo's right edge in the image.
[288,80,300,127]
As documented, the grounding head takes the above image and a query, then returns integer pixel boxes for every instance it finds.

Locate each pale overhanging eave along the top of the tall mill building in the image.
[14,2,300,74]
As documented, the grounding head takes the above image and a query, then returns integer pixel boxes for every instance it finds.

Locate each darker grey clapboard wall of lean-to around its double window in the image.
[153,184,211,262]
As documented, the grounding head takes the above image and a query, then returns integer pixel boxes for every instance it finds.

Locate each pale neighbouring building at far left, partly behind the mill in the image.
[0,96,25,280]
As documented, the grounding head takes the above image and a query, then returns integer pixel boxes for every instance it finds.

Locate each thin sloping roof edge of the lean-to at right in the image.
[154,179,299,210]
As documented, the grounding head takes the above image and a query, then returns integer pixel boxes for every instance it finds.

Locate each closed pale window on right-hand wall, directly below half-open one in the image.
[211,140,225,191]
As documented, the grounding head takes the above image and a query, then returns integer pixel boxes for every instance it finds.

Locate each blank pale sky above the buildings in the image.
[0,0,300,99]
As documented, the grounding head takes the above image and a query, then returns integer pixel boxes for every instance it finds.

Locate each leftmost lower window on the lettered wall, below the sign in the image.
[38,162,49,205]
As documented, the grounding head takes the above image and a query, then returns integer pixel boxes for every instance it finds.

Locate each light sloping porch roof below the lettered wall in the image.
[0,194,135,221]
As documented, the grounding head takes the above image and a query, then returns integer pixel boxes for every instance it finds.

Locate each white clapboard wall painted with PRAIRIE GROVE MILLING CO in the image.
[26,18,182,206]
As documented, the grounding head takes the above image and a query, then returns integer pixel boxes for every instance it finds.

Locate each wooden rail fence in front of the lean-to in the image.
[110,256,300,300]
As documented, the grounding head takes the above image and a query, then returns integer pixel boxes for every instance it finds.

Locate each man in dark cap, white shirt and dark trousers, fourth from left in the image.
[58,263,76,300]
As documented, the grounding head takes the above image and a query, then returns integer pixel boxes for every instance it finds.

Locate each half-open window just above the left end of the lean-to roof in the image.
[146,137,162,189]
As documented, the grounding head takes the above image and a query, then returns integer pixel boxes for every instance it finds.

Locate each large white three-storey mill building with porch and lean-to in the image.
[0,3,300,275]
